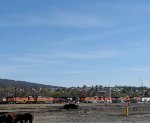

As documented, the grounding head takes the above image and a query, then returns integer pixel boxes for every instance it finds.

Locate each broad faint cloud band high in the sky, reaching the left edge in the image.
[0,10,113,28]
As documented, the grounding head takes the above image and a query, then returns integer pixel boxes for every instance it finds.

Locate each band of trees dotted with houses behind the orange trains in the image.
[0,85,150,98]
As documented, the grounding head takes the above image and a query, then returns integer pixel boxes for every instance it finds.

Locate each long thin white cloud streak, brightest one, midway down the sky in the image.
[10,51,122,64]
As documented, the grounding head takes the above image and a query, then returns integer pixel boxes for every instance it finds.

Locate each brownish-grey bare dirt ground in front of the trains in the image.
[0,103,150,123]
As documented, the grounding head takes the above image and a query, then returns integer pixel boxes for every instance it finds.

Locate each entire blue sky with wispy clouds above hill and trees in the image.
[0,0,150,87]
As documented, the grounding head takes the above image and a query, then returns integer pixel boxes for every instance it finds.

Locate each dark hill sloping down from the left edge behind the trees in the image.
[0,79,58,88]
